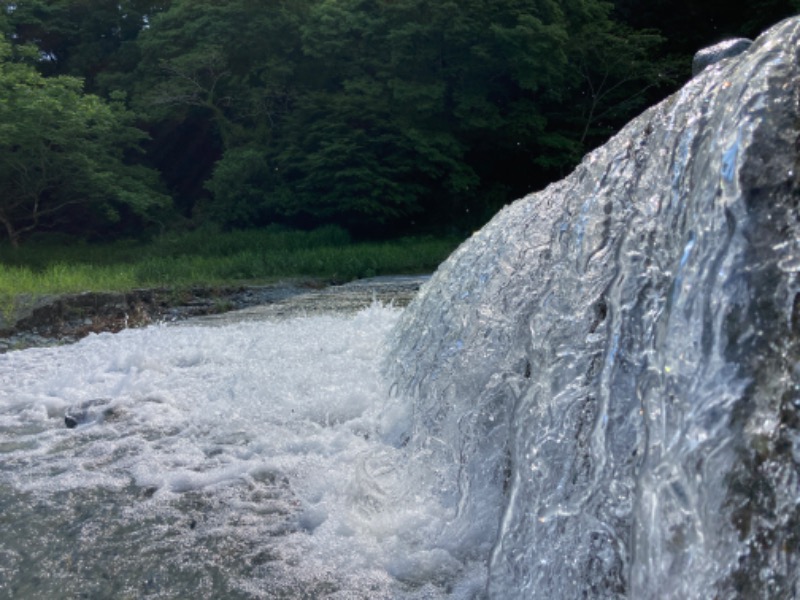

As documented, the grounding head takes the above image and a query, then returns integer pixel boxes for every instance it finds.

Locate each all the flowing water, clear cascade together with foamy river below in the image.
[0,20,800,600]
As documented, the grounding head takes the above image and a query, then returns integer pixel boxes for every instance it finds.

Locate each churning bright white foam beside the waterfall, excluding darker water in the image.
[0,306,488,597]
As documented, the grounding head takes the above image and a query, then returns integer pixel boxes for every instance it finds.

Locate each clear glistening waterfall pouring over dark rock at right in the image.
[388,19,800,599]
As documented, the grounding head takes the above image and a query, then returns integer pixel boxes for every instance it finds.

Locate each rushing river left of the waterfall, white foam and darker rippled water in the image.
[0,304,485,599]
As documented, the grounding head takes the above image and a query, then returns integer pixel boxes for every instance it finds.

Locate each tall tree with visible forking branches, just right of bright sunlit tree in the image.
[133,0,306,215]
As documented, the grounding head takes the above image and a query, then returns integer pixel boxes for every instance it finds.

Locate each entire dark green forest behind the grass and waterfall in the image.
[0,0,800,246]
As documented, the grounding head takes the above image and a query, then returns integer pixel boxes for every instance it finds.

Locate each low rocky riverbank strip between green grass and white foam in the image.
[0,276,427,353]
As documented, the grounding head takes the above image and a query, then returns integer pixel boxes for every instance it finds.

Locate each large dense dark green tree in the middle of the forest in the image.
[277,0,580,227]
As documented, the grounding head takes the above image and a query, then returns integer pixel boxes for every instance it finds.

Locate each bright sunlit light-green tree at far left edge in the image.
[0,40,169,246]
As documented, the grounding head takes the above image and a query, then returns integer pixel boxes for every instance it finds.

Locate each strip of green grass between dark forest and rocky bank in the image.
[0,227,460,304]
